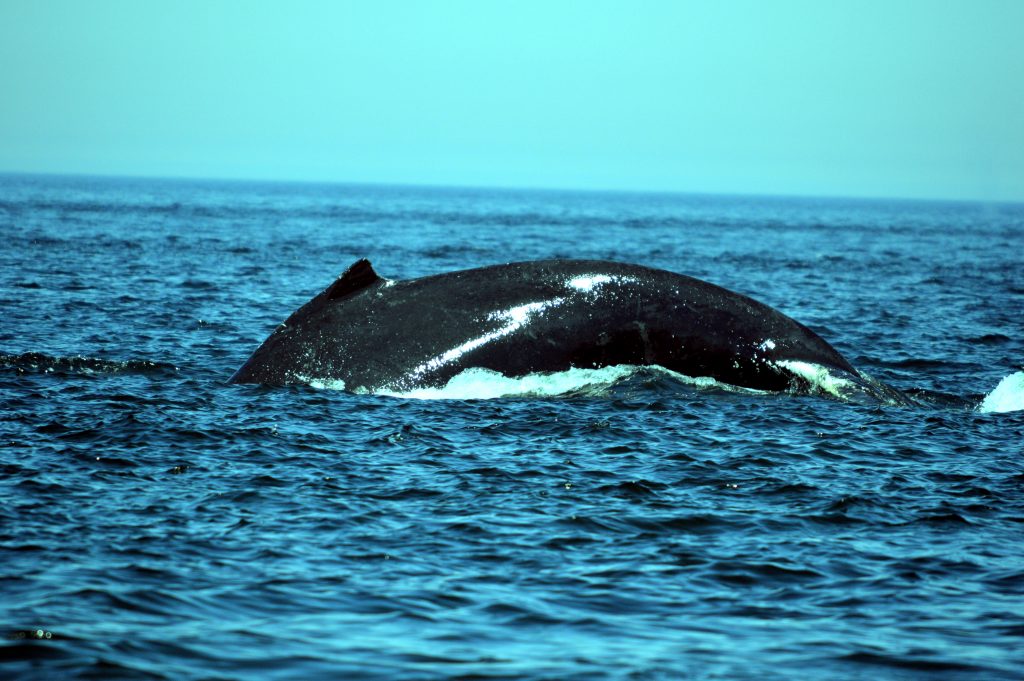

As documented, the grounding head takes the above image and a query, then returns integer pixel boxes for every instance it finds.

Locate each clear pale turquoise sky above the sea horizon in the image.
[0,0,1024,201]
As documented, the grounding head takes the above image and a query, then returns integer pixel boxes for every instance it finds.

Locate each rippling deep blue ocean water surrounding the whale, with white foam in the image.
[0,175,1024,681]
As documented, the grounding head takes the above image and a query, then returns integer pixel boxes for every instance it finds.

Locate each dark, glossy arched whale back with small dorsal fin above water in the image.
[229,259,899,401]
